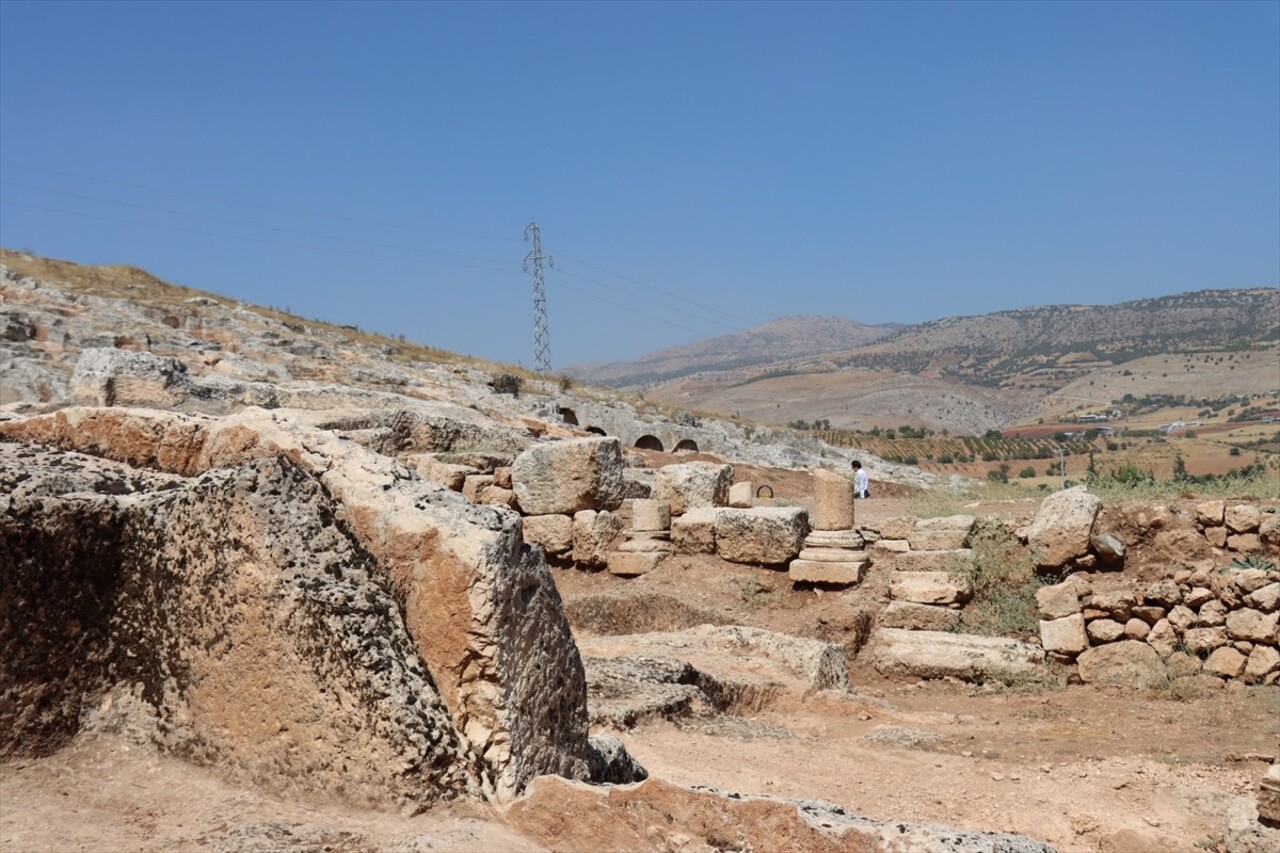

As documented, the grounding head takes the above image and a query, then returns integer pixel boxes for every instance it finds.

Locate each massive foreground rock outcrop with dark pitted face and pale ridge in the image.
[0,407,589,798]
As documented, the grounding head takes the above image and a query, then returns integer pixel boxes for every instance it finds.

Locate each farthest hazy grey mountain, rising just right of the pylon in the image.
[566,314,905,386]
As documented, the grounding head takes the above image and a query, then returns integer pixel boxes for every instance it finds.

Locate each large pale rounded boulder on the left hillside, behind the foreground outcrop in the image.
[67,348,191,409]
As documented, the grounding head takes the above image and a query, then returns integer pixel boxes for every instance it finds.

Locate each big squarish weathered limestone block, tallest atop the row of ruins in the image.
[511,437,622,515]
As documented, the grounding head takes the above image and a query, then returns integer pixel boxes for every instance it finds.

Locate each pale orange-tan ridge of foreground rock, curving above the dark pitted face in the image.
[0,407,586,798]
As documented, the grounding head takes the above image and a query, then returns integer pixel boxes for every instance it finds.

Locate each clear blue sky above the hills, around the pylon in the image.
[0,0,1280,368]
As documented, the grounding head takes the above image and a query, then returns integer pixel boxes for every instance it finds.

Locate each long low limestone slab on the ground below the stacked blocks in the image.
[870,628,1044,680]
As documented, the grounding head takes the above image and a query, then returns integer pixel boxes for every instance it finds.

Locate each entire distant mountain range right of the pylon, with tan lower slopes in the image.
[570,288,1280,432]
